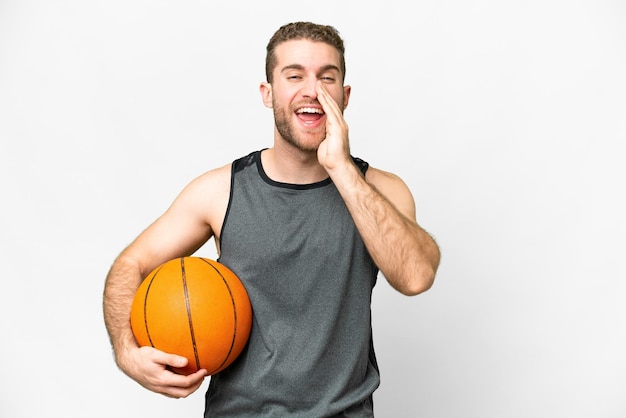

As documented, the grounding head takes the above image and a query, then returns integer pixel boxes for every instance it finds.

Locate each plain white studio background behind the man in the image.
[0,0,626,418]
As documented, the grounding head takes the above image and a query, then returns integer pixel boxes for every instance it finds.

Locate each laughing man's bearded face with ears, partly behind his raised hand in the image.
[261,40,350,151]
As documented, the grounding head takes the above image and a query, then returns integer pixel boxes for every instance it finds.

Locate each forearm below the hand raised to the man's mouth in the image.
[331,162,440,295]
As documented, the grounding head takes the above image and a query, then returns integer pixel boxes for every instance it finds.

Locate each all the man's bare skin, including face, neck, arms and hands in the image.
[103,40,440,398]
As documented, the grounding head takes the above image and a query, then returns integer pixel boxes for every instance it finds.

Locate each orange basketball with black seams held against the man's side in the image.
[130,257,252,375]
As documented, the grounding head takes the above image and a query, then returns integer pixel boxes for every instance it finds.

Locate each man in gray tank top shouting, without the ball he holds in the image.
[104,22,440,417]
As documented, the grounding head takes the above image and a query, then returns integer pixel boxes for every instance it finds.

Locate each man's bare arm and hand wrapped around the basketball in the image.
[103,166,230,397]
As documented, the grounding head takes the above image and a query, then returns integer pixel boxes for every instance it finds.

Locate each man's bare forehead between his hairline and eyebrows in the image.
[275,39,341,71]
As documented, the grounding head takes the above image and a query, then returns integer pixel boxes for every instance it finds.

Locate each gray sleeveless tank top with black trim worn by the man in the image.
[205,151,380,418]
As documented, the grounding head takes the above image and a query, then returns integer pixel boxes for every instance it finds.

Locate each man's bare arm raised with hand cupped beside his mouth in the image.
[317,84,440,295]
